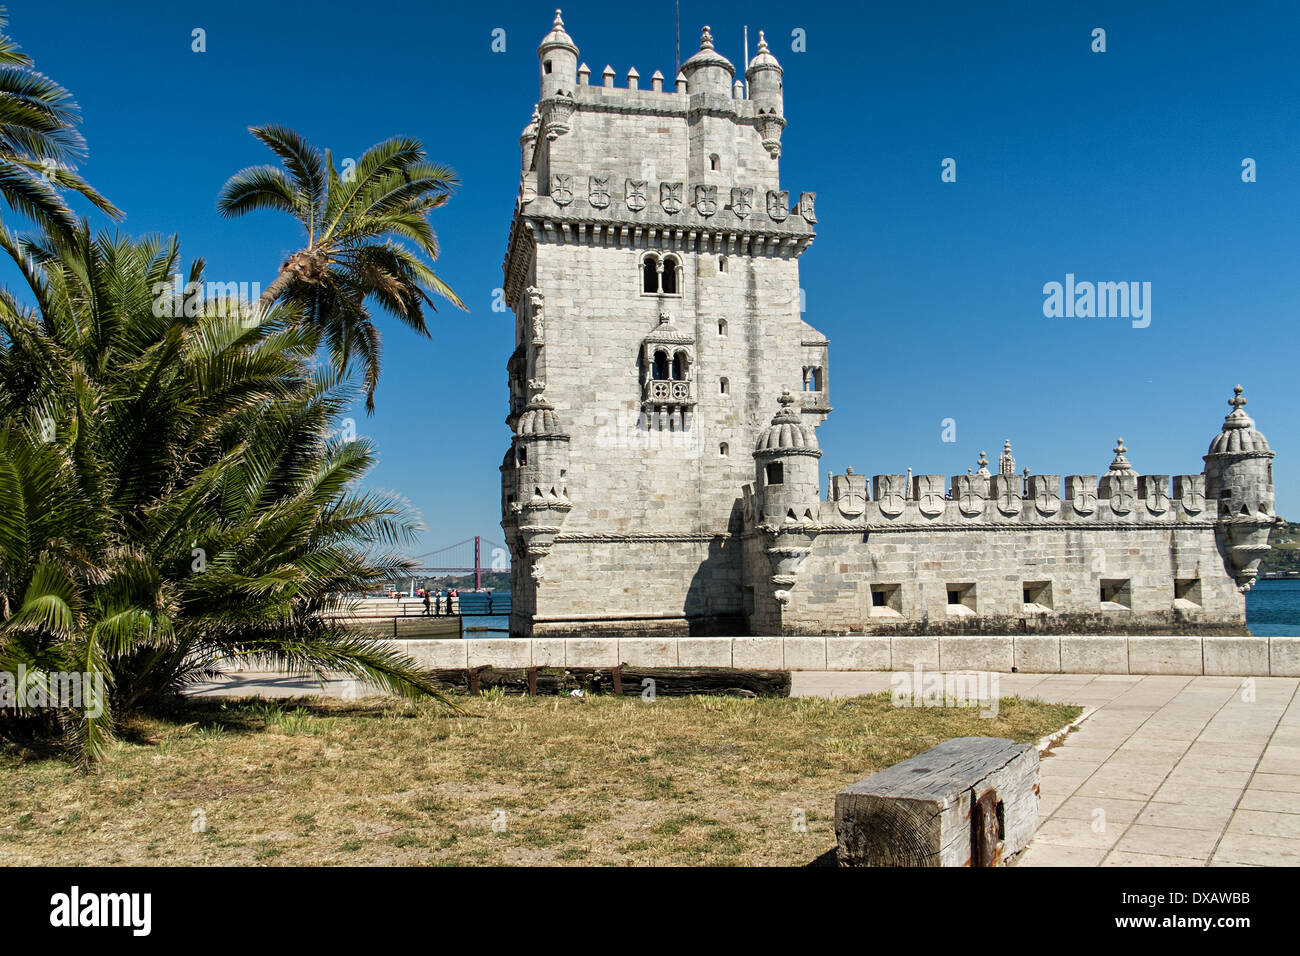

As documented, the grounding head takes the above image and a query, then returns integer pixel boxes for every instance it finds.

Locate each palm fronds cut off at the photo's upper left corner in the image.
[0,7,122,235]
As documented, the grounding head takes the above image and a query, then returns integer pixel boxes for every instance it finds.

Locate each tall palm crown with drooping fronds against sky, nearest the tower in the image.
[217,126,465,412]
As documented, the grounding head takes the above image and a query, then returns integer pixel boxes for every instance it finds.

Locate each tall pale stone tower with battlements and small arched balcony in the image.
[502,12,831,636]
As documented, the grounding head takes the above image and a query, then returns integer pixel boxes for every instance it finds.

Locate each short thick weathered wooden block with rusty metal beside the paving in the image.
[835,737,1039,866]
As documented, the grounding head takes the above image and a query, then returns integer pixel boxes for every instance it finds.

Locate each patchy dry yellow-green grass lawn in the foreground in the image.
[0,693,1079,865]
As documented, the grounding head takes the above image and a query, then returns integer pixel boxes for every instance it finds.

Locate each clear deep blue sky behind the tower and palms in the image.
[10,0,1300,549]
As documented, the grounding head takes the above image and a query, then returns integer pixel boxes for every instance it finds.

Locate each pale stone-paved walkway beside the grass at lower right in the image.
[793,671,1300,866]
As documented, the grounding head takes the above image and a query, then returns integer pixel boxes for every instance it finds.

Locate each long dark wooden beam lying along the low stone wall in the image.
[434,666,790,697]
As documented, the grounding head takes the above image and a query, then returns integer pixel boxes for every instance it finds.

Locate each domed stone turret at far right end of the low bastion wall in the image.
[1205,385,1278,591]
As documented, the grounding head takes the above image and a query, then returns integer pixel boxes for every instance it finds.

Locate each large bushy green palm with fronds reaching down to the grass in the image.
[0,224,439,760]
